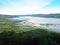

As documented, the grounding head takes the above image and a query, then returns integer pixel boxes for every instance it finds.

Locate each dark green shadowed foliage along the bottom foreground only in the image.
[0,29,60,45]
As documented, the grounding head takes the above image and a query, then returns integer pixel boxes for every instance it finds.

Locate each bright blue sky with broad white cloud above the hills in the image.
[0,0,60,15]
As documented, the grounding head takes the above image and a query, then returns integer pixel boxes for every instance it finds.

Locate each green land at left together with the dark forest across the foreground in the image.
[0,19,60,45]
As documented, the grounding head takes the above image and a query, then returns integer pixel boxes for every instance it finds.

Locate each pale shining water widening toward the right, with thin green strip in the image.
[12,16,60,32]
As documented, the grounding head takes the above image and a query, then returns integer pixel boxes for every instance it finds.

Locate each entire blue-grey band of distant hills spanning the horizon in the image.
[0,13,60,19]
